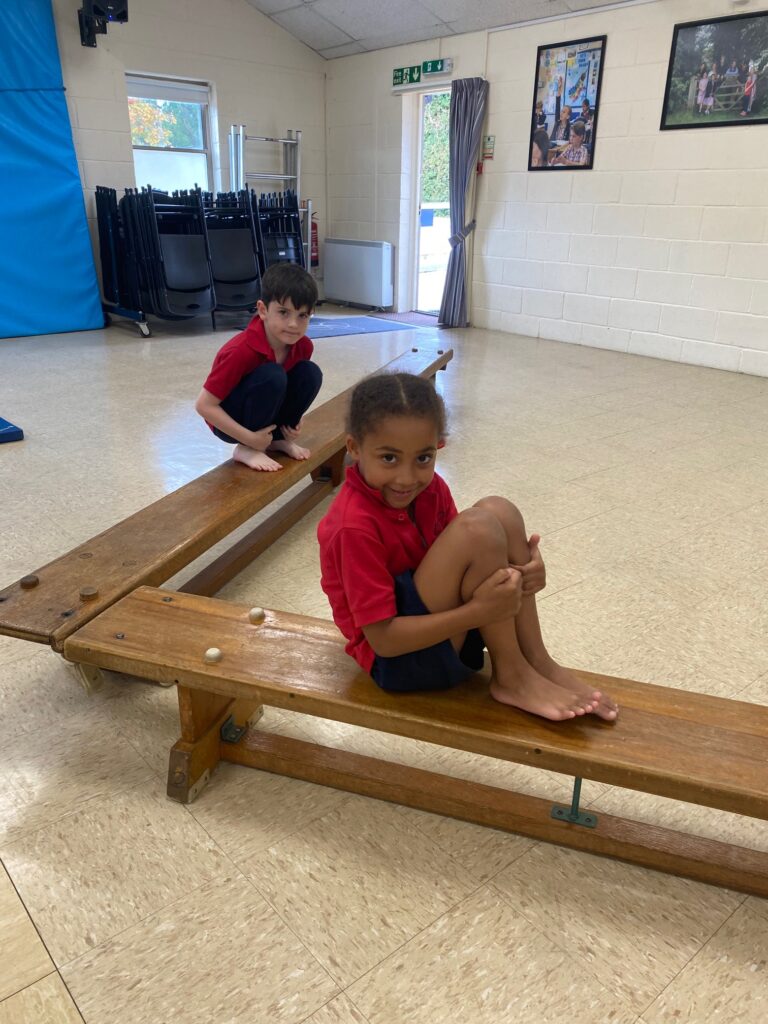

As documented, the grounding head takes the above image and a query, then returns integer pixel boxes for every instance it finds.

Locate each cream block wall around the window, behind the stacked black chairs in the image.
[53,0,327,263]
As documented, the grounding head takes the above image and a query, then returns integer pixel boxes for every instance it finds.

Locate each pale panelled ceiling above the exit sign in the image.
[248,0,636,59]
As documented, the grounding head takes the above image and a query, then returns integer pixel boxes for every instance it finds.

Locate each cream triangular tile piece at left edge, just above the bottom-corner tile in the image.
[0,864,53,999]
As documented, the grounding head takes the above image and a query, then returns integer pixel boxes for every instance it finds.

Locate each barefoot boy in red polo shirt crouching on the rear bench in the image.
[195,263,323,471]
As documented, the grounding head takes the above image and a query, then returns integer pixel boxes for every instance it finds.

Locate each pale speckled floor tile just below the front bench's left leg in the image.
[3,779,230,967]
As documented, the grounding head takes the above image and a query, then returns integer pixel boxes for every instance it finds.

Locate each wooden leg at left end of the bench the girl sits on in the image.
[167,686,261,804]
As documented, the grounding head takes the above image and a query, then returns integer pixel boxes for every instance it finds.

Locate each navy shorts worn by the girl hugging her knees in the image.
[371,571,484,693]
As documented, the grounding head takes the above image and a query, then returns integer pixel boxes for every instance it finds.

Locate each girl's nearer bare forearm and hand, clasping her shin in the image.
[362,568,522,657]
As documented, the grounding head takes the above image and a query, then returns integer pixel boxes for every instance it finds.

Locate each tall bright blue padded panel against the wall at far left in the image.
[0,0,103,338]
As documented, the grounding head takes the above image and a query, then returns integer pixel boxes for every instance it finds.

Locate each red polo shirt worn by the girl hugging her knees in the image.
[317,466,458,672]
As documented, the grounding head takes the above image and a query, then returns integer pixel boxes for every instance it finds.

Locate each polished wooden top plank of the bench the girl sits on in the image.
[65,588,768,818]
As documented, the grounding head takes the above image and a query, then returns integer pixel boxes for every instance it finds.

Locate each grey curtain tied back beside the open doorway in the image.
[437,78,488,327]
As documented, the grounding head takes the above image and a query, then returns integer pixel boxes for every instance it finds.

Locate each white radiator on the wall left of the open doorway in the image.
[324,239,394,308]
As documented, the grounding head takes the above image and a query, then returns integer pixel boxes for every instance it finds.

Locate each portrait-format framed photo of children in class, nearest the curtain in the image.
[528,36,606,171]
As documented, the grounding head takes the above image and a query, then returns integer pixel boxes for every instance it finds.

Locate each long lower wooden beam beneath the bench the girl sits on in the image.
[221,732,768,897]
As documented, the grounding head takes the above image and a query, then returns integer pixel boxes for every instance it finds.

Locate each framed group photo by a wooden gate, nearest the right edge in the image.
[662,11,768,130]
